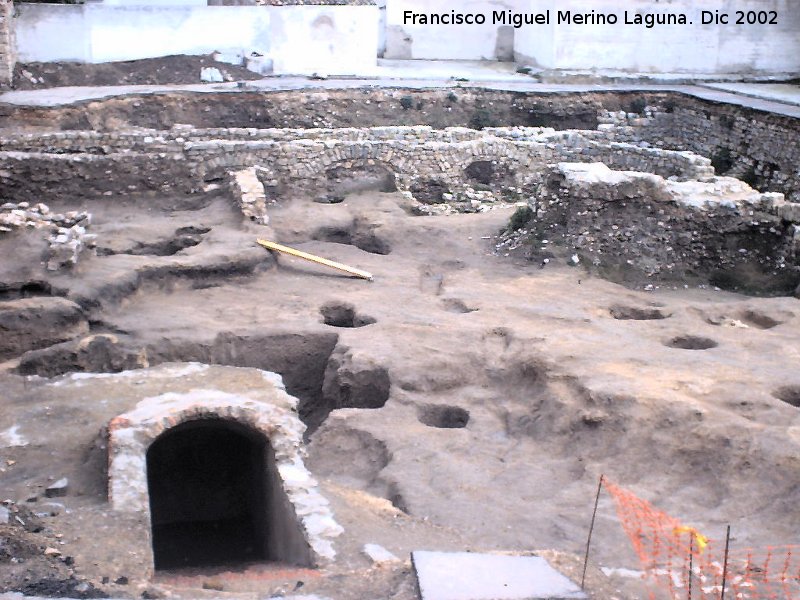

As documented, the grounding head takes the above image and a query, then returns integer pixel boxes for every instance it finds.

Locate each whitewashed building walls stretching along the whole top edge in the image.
[7,0,800,76]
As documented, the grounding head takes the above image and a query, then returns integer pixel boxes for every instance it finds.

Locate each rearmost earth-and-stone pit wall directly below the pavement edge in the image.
[0,88,800,199]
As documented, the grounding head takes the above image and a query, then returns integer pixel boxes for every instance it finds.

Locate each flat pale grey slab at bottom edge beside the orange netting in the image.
[411,551,586,600]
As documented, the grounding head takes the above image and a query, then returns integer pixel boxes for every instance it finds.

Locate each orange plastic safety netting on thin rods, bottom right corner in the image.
[603,478,800,600]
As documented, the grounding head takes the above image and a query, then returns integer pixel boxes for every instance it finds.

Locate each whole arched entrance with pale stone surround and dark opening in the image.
[108,380,342,569]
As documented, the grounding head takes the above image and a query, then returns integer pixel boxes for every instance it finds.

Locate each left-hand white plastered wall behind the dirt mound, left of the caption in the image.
[11,0,378,74]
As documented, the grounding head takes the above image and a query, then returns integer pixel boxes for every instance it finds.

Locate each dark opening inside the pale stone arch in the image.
[147,419,272,569]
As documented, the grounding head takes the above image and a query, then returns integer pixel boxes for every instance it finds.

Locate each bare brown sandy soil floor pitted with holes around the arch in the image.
[0,182,800,599]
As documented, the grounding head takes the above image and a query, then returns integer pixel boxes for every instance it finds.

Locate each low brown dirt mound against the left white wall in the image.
[12,54,262,90]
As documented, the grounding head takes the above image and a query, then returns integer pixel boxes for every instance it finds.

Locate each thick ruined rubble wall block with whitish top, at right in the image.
[523,163,800,293]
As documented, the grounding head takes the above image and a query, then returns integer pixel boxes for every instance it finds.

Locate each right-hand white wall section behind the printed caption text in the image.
[386,0,800,75]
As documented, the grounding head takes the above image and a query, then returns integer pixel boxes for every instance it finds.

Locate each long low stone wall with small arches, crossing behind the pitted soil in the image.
[0,127,713,201]
